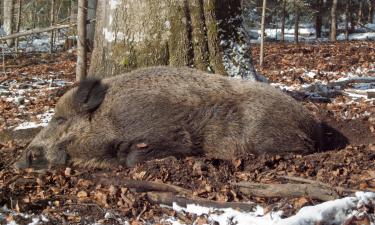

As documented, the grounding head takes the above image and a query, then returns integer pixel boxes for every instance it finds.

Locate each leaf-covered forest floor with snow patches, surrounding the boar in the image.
[0,41,375,225]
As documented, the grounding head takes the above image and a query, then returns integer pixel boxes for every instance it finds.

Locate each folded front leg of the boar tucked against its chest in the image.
[118,129,196,167]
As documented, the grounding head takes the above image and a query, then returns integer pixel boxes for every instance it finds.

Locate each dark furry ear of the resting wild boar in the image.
[73,79,108,113]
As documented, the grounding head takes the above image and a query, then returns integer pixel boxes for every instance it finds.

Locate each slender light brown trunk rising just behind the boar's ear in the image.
[76,0,87,81]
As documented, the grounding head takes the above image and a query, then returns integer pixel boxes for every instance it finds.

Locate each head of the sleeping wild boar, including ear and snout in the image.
[15,80,107,169]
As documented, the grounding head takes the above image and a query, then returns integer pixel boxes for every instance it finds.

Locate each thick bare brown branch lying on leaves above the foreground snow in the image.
[234,182,339,201]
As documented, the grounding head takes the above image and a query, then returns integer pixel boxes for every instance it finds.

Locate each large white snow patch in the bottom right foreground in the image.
[159,192,375,225]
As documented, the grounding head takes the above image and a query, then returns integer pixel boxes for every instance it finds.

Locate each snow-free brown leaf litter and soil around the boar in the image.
[0,42,375,224]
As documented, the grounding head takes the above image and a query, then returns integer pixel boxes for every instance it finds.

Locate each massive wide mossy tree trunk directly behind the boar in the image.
[89,0,257,79]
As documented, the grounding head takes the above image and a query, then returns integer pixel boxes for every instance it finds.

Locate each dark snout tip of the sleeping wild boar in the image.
[14,146,49,169]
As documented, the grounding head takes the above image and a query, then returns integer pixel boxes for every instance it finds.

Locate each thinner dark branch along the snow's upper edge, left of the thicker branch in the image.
[147,192,256,212]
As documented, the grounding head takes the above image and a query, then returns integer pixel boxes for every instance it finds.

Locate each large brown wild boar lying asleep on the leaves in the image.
[16,67,321,169]
